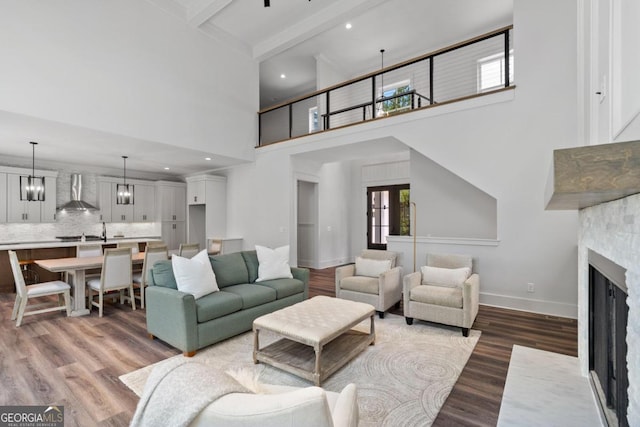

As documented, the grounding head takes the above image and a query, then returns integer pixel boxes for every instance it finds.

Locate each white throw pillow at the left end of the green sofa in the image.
[171,250,220,299]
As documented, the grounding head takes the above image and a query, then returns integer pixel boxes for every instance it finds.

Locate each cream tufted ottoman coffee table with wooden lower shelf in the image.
[253,296,375,386]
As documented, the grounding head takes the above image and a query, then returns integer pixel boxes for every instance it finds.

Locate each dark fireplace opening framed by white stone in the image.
[589,251,629,426]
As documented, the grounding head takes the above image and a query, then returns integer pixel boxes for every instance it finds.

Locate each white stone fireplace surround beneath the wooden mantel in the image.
[578,194,640,425]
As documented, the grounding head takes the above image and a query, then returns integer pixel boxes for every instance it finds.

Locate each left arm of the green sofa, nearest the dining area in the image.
[145,286,198,353]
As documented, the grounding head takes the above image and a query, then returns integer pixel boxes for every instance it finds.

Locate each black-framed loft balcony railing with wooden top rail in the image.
[258,25,514,146]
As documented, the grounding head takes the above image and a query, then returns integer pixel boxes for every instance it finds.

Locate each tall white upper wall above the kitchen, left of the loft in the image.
[0,0,259,159]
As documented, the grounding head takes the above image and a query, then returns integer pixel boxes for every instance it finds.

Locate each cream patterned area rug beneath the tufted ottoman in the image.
[120,314,480,427]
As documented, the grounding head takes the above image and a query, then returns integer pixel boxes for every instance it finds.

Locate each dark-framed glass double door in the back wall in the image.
[367,184,411,250]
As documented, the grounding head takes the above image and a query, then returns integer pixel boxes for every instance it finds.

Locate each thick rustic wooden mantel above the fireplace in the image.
[546,141,640,210]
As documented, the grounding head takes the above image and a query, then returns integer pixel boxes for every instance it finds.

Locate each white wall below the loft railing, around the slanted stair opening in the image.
[228,0,578,317]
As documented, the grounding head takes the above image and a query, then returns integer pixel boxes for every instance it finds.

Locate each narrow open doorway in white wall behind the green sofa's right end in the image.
[297,180,318,268]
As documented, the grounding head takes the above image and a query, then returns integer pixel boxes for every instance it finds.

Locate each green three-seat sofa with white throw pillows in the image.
[146,251,309,357]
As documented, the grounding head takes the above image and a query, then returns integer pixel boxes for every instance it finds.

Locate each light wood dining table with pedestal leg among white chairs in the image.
[34,252,144,317]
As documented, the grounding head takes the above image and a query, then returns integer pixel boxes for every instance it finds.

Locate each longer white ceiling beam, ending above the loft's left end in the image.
[253,0,386,61]
